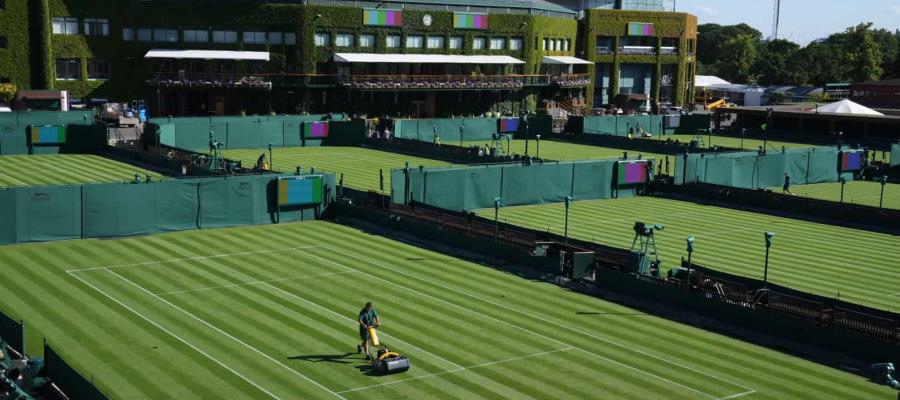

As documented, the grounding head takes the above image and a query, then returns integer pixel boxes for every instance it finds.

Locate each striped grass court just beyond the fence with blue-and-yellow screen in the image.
[225,146,449,193]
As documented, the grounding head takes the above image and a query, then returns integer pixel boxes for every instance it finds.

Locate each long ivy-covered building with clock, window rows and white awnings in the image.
[0,0,696,116]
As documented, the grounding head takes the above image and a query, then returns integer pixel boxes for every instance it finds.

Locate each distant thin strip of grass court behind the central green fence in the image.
[464,139,665,161]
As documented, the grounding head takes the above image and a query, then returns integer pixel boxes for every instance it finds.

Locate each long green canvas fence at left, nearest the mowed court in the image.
[0,175,336,244]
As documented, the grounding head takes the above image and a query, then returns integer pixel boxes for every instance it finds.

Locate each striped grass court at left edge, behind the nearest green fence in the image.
[0,154,162,187]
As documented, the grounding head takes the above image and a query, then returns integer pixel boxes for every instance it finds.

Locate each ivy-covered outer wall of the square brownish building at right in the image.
[579,9,697,106]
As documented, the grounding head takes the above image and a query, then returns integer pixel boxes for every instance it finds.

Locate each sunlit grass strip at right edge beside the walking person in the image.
[770,181,900,210]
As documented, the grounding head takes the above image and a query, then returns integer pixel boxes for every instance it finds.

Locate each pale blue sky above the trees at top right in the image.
[675,0,900,46]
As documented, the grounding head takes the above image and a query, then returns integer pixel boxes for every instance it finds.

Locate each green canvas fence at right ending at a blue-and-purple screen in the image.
[675,147,840,189]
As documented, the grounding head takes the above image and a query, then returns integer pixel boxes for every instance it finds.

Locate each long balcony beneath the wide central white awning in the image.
[338,75,551,91]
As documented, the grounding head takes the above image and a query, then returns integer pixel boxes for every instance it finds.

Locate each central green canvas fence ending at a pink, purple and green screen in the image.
[391,159,653,211]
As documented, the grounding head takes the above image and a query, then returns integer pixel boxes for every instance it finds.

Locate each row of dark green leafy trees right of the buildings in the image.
[697,23,900,86]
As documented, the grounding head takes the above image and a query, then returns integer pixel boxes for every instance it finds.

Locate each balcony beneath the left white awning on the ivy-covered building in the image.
[146,71,272,91]
